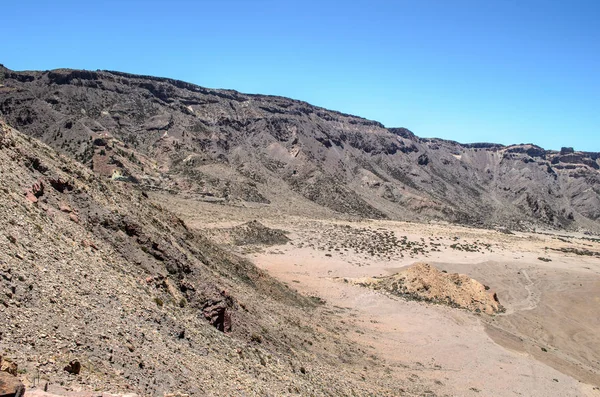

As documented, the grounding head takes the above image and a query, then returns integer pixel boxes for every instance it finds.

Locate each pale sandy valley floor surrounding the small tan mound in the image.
[157,196,600,396]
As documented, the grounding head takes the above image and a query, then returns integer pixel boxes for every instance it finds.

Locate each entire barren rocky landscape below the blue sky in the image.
[0,65,600,397]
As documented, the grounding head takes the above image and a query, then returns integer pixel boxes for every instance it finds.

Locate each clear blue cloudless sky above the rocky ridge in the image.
[0,0,600,151]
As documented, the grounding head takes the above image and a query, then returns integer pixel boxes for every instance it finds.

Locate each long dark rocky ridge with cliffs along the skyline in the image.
[0,68,600,232]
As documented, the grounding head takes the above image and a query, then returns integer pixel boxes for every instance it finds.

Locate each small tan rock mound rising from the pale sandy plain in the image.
[354,263,504,314]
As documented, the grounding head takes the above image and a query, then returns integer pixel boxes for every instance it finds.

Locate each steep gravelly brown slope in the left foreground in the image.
[0,120,434,396]
